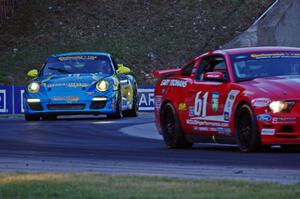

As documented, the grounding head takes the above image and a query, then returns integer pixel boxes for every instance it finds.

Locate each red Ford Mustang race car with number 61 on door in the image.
[154,47,300,152]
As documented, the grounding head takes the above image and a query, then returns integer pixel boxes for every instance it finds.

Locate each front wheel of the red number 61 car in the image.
[235,104,262,152]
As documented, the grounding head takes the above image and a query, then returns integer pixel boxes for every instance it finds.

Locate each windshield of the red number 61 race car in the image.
[231,52,300,81]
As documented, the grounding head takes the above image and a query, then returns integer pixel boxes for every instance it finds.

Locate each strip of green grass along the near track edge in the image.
[0,174,300,199]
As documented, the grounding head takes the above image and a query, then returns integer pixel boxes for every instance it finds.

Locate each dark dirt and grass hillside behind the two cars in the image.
[0,0,274,85]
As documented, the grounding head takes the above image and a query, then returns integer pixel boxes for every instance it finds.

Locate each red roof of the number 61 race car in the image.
[214,46,300,55]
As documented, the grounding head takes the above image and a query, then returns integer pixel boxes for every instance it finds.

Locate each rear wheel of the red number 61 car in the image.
[160,103,193,148]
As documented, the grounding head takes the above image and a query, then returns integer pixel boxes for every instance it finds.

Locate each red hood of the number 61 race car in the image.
[241,76,300,100]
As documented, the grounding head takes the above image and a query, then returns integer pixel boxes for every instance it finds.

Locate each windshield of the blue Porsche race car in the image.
[42,55,113,76]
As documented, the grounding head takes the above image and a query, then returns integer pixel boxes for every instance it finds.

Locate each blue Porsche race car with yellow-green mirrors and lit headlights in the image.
[24,52,138,121]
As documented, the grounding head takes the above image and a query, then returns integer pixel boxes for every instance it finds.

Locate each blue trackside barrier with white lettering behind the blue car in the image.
[0,86,154,115]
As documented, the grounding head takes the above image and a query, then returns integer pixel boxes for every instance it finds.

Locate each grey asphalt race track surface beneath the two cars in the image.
[0,114,300,183]
